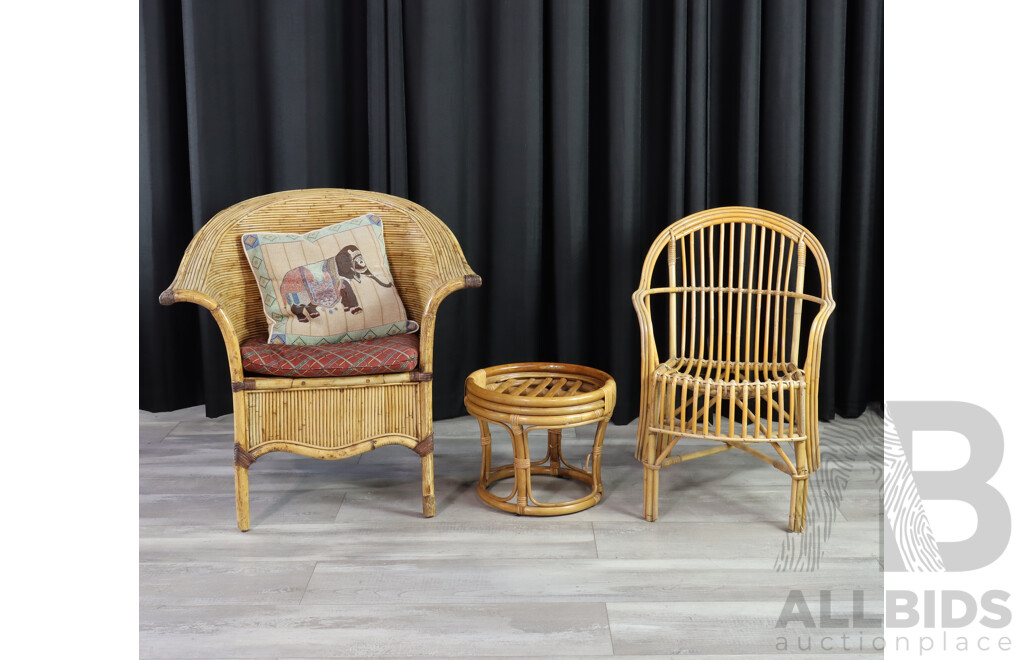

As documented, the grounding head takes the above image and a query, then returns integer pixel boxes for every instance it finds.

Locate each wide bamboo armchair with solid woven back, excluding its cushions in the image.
[160,188,481,531]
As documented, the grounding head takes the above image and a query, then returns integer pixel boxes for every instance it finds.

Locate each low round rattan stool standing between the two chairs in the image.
[466,362,615,516]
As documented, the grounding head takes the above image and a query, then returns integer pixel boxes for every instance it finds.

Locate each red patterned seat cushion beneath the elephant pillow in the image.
[242,335,420,378]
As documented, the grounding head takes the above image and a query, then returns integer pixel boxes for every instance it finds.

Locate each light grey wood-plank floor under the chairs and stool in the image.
[139,407,883,659]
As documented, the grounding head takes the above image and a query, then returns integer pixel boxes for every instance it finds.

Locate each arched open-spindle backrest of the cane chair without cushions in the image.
[634,207,833,382]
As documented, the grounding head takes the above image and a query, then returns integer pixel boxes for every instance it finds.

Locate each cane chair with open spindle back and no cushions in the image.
[633,207,836,532]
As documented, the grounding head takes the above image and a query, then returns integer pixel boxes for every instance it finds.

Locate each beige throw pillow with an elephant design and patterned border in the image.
[242,214,420,346]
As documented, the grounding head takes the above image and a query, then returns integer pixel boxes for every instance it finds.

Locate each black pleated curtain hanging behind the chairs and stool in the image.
[139,0,882,423]
